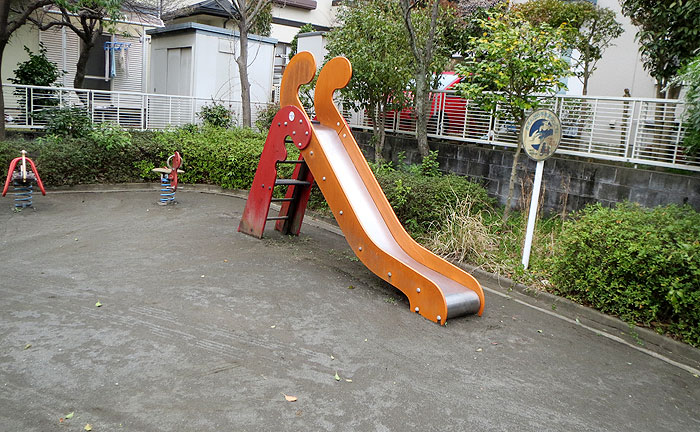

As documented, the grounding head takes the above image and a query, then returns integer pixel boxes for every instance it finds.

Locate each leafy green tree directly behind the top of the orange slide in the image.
[326,0,412,162]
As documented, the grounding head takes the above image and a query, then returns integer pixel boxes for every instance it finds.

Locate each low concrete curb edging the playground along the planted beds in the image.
[39,183,700,374]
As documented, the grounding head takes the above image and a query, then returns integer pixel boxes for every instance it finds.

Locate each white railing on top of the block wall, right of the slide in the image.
[343,91,700,171]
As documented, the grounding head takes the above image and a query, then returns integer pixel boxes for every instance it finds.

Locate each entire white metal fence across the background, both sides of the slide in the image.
[2,84,700,171]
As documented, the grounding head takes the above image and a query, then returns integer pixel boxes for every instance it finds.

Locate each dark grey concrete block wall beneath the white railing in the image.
[353,131,700,214]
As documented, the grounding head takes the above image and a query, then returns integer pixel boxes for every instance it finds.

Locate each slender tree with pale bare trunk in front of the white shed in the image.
[216,0,272,128]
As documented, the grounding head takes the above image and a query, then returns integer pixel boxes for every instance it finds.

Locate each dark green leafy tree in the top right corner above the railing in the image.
[620,0,700,99]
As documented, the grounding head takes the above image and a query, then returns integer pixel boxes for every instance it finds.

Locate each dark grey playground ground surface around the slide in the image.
[0,185,700,431]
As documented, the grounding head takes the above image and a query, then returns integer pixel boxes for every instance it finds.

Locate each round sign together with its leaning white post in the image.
[520,109,561,269]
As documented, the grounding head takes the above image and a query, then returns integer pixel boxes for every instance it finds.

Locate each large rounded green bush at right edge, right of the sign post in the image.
[551,203,700,346]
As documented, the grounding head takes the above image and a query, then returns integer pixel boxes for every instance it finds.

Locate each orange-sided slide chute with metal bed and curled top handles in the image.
[239,52,484,324]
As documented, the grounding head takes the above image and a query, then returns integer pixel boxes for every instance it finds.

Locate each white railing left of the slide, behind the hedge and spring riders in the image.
[2,84,274,129]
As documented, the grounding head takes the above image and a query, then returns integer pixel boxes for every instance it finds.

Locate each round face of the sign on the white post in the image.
[520,109,561,161]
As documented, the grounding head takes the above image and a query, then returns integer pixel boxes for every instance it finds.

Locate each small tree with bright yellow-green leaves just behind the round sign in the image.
[457,14,570,221]
